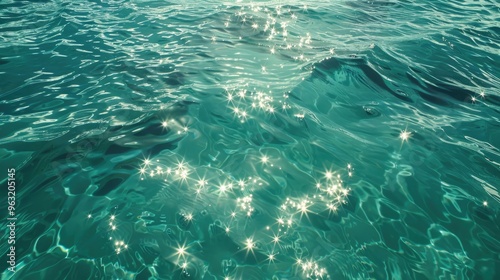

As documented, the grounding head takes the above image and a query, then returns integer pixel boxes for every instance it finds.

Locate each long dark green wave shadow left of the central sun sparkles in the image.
[24,101,195,196]
